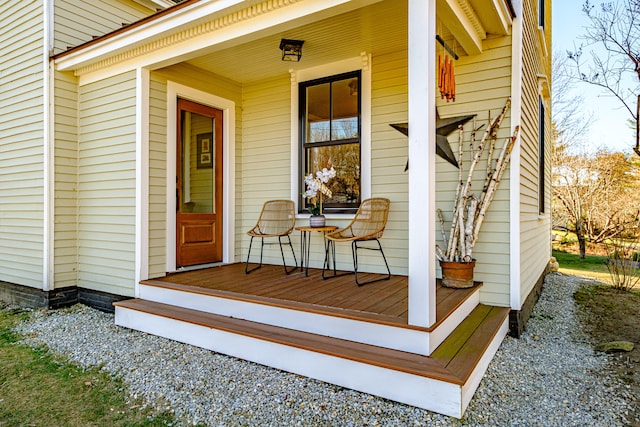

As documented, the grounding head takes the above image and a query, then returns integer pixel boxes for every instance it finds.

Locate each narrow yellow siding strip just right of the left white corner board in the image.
[54,72,78,288]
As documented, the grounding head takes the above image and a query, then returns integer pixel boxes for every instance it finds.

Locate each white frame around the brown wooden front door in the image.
[165,81,236,272]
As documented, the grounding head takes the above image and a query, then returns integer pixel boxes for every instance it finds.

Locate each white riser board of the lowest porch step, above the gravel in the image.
[116,306,507,418]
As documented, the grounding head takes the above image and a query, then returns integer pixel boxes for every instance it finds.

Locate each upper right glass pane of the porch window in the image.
[331,77,359,141]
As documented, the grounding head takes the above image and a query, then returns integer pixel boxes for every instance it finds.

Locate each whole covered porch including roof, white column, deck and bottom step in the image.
[56,0,511,417]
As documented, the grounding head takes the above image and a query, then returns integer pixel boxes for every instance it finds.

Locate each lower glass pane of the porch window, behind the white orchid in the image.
[307,143,360,208]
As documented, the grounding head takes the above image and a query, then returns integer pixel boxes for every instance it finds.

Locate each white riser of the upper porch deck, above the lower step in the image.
[139,280,480,356]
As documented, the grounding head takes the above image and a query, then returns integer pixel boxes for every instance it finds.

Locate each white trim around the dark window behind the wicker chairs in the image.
[289,52,371,219]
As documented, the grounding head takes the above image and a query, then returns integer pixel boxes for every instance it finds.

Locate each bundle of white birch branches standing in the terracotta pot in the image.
[436,98,519,262]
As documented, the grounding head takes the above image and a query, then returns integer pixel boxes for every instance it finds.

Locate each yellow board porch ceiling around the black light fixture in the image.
[178,0,511,83]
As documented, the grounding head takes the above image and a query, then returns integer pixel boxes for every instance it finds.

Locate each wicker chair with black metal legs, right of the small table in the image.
[322,198,391,286]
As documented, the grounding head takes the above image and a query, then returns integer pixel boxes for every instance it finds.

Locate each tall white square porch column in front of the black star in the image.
[408,0,436,327]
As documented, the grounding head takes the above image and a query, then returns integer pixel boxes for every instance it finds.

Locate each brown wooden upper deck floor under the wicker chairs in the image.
[141,263,475,329]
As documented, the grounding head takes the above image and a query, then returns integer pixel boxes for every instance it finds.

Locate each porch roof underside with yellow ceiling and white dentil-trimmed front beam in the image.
[55,0,511,83]
